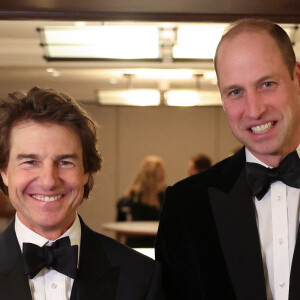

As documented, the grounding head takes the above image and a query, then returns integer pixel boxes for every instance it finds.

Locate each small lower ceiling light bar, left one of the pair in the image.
[97,89,160,106]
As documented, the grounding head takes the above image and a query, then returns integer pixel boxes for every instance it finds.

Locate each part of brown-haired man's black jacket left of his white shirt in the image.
[0,222,32,300]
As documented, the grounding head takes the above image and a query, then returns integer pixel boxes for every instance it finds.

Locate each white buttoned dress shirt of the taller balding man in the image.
[246,147,300,300]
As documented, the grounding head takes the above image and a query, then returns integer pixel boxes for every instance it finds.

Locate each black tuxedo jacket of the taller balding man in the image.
[156,149,300,300]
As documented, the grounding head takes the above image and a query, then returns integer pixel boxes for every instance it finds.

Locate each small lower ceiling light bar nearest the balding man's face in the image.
[164,90,222,106]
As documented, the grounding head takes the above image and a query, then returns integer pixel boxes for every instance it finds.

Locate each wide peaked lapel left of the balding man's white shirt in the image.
[209,170,267,300]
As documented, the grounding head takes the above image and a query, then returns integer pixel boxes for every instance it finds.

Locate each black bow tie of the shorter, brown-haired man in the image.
[23,237,78,279]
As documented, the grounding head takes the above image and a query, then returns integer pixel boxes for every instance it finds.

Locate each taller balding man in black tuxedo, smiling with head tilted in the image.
[156,19,300,300]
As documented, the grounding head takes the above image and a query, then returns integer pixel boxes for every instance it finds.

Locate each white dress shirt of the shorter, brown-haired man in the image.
[15,214,81,300]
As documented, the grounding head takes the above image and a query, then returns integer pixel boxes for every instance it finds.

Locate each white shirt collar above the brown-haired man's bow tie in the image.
[15,214,81,254]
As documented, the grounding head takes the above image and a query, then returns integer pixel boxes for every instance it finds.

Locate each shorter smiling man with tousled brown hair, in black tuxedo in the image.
[0,88,164,300]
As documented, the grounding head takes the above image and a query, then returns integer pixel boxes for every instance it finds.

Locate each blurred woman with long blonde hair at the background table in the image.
[117,155,166,247]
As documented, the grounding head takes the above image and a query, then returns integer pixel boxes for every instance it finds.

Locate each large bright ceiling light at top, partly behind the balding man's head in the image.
[38,22,298,63]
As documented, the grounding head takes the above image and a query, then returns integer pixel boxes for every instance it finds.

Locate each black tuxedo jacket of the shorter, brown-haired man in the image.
[0,220,164,300]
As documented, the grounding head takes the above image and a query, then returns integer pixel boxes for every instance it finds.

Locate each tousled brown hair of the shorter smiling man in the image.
[0,87,102,198]
